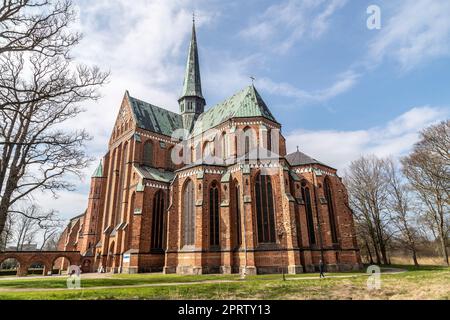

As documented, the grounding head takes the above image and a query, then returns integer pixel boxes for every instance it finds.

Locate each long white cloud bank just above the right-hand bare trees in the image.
[286,106,450,173]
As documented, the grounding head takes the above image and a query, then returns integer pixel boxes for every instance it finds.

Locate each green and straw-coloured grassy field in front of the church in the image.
[0,266,450,300]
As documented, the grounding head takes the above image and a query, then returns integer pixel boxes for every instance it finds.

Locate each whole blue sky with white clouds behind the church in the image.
[37,0,450,222]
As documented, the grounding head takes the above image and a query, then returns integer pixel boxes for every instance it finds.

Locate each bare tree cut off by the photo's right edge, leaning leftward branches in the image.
[402,121,450,265]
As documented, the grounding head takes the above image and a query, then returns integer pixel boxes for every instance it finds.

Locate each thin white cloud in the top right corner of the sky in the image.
[369,0,450,71]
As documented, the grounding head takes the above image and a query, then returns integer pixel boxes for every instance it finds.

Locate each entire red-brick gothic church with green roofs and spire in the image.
[59,24,361,274]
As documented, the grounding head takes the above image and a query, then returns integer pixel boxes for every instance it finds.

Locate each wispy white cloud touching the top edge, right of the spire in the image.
[241,0,347,53]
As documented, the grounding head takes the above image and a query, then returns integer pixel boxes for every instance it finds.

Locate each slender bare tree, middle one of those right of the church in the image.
[386,159,420,266]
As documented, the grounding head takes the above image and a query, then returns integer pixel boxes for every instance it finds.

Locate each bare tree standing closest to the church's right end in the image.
[345,156,392,264]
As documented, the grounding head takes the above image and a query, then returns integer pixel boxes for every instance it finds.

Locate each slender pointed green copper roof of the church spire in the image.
[181,22,203,98]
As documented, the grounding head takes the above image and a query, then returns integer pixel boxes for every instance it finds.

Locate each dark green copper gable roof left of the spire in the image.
[128,96,183,137]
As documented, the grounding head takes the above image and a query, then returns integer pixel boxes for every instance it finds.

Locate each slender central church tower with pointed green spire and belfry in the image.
[178,20,206,132]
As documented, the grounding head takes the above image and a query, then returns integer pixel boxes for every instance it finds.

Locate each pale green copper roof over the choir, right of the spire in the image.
[192,85,277,136]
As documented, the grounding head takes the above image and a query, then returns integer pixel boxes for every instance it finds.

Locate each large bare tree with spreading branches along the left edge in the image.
[0,1,108,232]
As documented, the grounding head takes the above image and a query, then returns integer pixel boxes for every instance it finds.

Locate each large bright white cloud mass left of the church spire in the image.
[28,0,216,225]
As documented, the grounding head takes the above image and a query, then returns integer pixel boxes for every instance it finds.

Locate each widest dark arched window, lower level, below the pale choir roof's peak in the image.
[255,174,276,243]
